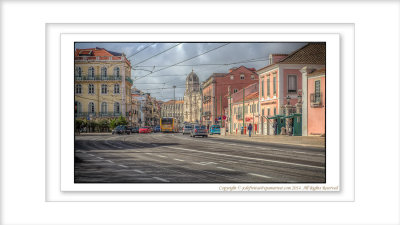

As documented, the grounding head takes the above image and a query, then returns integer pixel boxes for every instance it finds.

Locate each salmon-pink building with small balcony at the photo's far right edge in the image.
[300,67,326,136]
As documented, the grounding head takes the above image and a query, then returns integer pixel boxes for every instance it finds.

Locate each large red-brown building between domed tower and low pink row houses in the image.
[202,66,258,125]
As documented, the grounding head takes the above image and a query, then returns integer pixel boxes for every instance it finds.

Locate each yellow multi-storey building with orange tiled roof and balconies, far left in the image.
[75,48,133,121]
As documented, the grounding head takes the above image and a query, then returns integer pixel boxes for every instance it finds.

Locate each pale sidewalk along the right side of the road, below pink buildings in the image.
[208,133,325,147]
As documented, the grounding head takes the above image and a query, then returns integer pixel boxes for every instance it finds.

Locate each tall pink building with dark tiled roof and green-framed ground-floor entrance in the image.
[257,43,326,135]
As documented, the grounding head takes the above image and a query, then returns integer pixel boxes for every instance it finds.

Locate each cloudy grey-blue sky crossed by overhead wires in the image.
[75,42,305,101]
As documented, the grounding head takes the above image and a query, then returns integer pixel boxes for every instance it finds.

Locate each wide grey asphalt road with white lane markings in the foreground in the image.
[75,133,325,183]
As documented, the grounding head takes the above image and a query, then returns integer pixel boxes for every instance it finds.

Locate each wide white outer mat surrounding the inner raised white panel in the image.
[0,0,400,224]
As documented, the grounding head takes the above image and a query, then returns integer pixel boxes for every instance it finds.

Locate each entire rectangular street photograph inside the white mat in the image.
[74,42,326,183]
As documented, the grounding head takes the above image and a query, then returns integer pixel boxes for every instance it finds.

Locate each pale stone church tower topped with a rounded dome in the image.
[183,70,202,123]
